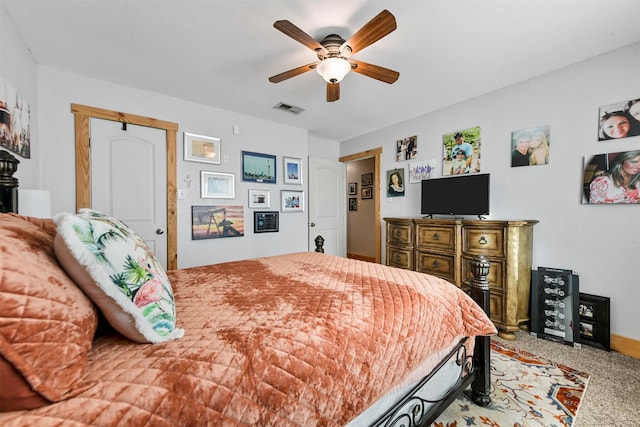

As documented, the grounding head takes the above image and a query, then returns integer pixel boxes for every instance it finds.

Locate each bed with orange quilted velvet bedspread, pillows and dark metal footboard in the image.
[0,209,496,426]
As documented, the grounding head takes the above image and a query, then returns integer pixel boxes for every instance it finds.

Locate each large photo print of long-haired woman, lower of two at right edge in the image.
[582,150,640,204]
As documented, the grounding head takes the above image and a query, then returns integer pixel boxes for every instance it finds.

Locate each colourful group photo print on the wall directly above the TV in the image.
[442,126,481,176]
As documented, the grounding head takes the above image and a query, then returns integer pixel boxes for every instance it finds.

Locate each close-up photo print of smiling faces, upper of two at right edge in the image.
[598,98,640,141]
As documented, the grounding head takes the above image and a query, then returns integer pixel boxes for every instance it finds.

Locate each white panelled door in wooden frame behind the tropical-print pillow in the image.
[90,118,167,268]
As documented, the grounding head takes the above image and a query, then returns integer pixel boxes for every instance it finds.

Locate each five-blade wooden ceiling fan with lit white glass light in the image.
[269,10,400,102]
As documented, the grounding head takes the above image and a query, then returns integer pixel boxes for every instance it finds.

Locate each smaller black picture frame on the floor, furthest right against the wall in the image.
[578,292,611,351]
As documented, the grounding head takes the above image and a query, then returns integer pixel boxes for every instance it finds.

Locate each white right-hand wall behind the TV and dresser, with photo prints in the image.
[340,44,640,340]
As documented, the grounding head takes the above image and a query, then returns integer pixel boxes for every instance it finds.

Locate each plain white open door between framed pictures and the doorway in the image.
[309,157,347,257]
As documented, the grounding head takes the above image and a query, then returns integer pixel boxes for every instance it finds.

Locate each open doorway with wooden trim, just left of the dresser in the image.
[339,148,382,264]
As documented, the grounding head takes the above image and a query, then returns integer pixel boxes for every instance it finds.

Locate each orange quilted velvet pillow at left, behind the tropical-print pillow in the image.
[0,214,98,411]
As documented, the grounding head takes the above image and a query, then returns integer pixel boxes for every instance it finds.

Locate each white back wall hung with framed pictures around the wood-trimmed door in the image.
[38,67,316,268]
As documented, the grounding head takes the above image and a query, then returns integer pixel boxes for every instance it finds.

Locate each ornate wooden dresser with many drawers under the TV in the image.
[384,218,538,340]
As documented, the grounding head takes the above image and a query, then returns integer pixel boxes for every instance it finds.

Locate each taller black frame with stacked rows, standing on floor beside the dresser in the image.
[530,267,580,346]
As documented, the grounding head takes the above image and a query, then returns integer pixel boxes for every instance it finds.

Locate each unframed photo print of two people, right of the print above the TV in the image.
[511,126,551,167]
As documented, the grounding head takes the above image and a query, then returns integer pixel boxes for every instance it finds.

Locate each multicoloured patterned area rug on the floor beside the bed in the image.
[433,341,589,427]
